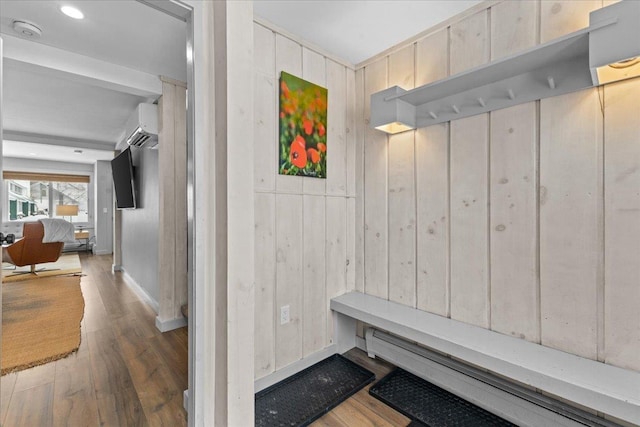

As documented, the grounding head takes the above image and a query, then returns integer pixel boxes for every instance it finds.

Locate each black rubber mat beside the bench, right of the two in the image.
[369,368,515,427]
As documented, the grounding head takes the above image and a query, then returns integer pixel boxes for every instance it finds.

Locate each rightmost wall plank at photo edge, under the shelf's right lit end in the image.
[604,78,640,371]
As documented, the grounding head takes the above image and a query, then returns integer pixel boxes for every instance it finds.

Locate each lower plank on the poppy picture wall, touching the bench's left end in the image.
[324,196,352,345]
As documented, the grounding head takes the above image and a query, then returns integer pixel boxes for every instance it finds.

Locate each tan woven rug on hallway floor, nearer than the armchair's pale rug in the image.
[2,276,84,375]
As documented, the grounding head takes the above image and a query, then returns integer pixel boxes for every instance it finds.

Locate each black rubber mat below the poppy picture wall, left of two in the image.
[256,354,376,427]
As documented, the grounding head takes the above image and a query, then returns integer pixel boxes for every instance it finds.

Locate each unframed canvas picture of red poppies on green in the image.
[278,71,327,178]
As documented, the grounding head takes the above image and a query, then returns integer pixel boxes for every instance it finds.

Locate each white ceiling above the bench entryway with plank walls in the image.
[253,0,480,64]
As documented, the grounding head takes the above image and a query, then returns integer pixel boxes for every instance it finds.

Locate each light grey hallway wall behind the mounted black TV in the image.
[121,148,162,307]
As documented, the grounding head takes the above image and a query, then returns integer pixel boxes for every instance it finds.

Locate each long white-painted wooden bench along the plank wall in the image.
[331,292,640,425]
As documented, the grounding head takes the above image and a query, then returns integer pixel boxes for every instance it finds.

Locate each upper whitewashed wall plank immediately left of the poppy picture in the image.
[253,24,279,191]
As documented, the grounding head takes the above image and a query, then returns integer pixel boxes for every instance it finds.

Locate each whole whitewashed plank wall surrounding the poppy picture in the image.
[253,23,362,378]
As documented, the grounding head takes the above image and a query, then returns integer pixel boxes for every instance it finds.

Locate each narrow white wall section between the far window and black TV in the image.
[93,160,113,255]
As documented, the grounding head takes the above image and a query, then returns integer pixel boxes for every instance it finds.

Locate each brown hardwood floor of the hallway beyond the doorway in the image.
[0,254,188,427]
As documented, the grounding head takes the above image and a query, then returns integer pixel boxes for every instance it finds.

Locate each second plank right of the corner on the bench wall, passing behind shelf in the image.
[388,45,416,307]
